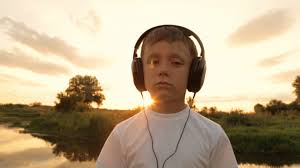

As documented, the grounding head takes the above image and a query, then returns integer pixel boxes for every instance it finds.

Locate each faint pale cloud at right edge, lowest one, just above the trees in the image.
[269,68,300,84]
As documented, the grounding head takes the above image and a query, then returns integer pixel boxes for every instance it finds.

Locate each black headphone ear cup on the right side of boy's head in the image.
[187,57,206,93]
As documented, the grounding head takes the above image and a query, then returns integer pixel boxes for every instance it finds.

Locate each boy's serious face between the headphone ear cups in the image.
[142,41,192,103]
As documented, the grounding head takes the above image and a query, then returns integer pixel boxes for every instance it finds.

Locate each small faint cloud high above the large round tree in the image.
[70,10,100,34]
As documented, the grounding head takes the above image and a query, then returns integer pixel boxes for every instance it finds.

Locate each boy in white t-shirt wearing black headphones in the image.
[96,25,238,168]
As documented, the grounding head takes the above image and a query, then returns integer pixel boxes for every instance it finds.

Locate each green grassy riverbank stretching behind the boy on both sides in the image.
[0,105,300,160]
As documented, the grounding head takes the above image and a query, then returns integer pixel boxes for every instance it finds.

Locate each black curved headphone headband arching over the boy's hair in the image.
[133,25,205,59]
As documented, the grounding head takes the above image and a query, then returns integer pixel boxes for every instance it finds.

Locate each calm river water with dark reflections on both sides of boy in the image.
[0,125,300,168]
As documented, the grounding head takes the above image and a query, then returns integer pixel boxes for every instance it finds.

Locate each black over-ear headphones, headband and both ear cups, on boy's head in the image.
[131,25,206,93]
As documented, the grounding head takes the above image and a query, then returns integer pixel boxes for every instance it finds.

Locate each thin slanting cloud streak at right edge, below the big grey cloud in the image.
[258,49,299,67]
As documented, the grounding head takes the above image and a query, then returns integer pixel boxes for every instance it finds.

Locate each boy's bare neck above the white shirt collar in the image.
[150,101,186,114]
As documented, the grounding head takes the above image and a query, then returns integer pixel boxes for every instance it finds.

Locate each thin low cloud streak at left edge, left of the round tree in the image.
[0,73,44,87]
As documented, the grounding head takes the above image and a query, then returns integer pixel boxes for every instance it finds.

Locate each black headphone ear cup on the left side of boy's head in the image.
[131,57,147,92]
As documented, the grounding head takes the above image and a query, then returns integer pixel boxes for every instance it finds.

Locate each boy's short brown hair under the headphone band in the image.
[141,26,198,57]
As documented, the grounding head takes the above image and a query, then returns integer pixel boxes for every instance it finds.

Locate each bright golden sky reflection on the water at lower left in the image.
[0,125,95,168]
